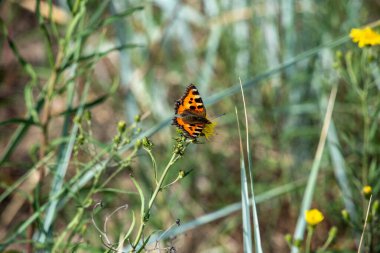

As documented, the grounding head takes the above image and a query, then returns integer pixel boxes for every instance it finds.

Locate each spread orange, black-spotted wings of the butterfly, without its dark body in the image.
[173,84,206,139]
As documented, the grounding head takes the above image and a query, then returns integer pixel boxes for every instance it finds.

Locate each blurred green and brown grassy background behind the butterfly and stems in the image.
[0,0,380,252]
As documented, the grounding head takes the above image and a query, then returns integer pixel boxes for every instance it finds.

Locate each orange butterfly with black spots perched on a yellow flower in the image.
[172,84,213,139]
